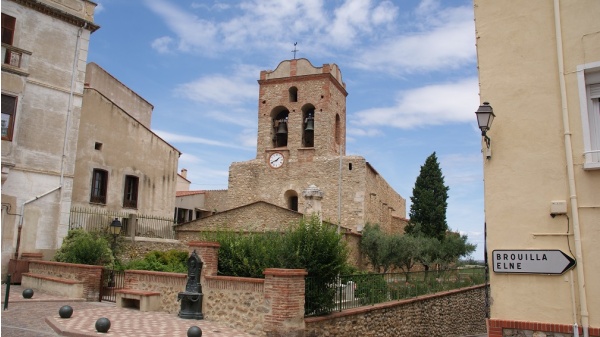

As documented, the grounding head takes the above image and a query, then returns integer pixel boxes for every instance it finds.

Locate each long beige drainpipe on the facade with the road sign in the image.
[554,0,589,337]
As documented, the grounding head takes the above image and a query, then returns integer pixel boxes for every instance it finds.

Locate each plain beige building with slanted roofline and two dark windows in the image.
[73,63,181,222]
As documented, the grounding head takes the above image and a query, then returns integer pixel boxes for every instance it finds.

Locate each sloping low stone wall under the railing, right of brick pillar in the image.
[305,285,486,337]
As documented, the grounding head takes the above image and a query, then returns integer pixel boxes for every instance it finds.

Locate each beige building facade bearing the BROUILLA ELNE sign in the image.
[474,0,600,337]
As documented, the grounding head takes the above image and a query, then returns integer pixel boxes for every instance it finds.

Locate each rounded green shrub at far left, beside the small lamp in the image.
[54,229,113,266]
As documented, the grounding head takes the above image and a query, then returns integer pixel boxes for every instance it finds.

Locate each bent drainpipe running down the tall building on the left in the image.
[15,22,87,259]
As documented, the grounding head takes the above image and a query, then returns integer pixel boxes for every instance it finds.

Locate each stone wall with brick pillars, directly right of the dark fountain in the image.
[188,241,307,337]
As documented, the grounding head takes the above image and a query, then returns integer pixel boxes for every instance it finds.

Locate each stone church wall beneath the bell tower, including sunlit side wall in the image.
[228,156,406,231]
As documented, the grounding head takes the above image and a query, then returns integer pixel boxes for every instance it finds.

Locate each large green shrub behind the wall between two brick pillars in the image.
[202,217,349,314]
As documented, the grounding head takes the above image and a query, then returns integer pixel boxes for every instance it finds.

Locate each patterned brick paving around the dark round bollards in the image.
[1,284,251,337]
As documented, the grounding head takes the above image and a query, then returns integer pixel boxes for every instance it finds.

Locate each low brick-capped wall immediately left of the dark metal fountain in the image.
[124,270,187,314]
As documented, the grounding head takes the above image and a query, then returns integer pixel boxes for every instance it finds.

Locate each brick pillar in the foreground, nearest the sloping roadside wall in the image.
[264,268,308,337]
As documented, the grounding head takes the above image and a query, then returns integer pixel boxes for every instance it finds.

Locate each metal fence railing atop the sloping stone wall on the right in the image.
[304,267,485,316]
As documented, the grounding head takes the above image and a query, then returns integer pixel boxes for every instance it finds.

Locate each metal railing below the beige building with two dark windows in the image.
[69,207,175,239]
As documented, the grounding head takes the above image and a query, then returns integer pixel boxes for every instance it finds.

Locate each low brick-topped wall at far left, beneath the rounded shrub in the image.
[24,261,102,302]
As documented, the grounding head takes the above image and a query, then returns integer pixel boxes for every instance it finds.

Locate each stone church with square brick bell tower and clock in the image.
[175,59,406,236]
